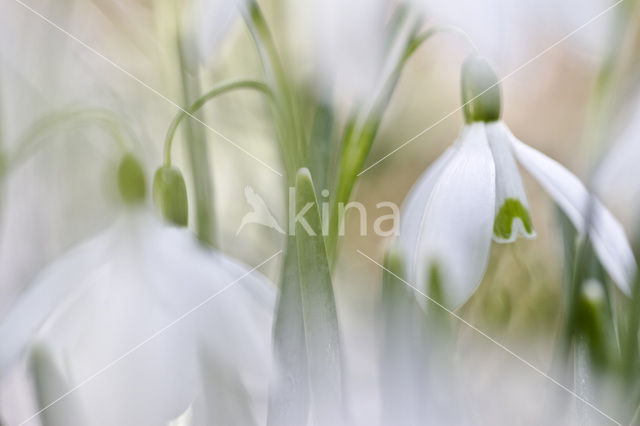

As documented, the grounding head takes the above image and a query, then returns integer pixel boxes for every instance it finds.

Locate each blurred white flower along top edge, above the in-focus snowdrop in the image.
[412,0,615,63]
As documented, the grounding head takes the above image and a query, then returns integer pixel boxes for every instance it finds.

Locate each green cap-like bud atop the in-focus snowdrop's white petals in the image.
[461,56,501,123]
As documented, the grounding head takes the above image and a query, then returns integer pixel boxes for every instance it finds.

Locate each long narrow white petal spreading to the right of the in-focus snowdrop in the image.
[511,135,636,294]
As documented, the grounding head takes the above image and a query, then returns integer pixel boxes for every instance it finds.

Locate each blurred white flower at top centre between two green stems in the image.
[307,0,417,105]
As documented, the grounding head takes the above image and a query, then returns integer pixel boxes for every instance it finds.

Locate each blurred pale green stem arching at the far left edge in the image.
[6,107,133,174]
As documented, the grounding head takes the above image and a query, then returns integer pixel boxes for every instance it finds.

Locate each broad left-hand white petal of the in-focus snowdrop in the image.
[399,123,495,309]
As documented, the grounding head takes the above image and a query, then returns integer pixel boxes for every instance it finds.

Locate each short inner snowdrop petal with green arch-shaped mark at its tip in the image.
[486,121,536,243]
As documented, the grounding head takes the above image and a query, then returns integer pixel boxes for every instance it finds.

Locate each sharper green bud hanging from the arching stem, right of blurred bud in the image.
[153,165,189,226]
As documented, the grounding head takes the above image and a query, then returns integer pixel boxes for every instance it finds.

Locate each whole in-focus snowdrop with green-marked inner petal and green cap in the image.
[399,57,635,308]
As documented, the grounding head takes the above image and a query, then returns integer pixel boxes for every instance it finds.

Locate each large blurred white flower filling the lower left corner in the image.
[0,211,275,425]
